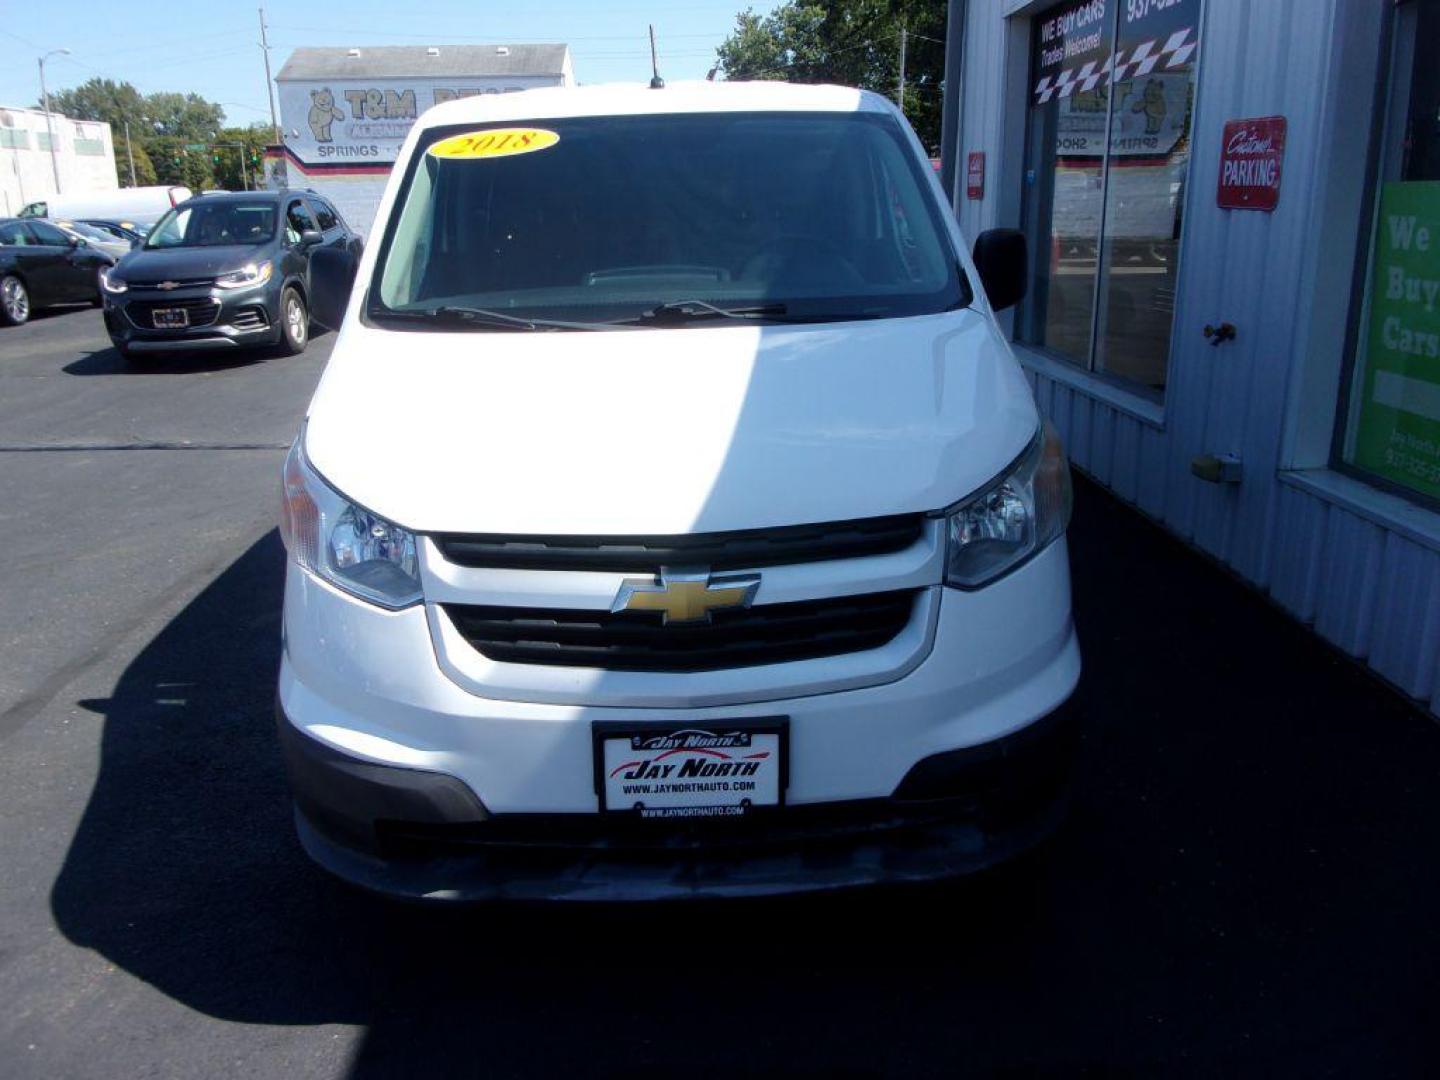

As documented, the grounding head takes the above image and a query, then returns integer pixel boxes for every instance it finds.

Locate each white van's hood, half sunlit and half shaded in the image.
[305,310,1038,536]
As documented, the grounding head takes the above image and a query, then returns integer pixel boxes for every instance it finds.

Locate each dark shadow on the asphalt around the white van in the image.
[52,487,1440,1077]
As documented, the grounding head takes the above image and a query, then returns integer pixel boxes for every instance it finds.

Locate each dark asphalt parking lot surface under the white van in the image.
[0,310,1440,1077]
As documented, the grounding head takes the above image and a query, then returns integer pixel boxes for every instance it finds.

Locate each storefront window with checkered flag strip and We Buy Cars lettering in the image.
[1018,0,1200,395]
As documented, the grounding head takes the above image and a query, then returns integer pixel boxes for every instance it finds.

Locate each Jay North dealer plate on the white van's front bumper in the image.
[595,717,788,818]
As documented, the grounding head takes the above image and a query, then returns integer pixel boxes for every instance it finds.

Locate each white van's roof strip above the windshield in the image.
[419,81,894,128]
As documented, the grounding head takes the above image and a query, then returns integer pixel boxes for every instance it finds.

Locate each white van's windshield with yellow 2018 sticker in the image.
[369,112,971,330]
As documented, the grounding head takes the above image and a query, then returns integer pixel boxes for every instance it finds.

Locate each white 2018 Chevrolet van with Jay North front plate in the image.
[278,84,1080,900]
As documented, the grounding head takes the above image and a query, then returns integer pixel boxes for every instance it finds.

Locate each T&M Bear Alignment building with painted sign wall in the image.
[266,45,575,233]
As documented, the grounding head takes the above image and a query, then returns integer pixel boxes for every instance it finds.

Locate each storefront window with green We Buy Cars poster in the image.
[1338,0,1440,503]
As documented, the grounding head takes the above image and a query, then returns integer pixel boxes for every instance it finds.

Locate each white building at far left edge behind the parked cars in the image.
[0,108,120,217]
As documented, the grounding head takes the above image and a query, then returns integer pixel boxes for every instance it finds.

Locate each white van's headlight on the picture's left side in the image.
[279,433,420,608]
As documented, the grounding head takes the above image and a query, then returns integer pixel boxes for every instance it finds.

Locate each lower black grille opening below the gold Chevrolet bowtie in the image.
[444,589,916,671]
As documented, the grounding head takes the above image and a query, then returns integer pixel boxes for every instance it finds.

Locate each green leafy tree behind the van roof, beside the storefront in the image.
[716,0,946,153]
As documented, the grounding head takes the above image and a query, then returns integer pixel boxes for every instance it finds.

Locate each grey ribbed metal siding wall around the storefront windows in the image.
[958,0,1440,713]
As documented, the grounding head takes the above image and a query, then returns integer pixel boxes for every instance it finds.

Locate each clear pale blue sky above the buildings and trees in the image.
[0,0,773,125]
